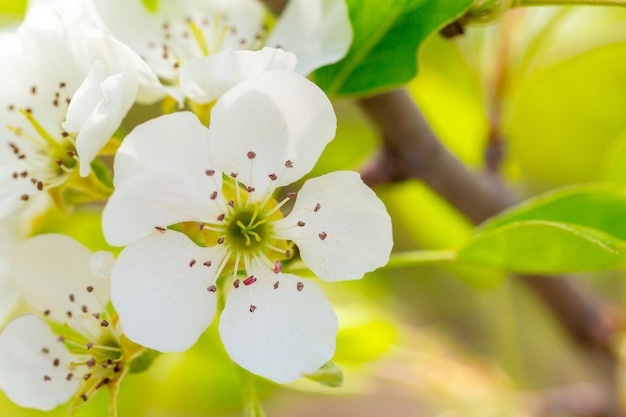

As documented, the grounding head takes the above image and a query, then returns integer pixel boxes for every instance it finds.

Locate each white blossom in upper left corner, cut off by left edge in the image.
[0,2,162,218]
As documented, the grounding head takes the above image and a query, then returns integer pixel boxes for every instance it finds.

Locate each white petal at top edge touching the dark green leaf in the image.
[266,0,352,75]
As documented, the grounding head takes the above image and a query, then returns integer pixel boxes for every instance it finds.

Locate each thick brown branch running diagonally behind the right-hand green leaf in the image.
[359,90,621,416]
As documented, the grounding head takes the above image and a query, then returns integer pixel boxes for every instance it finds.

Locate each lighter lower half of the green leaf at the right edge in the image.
[456,220,626,274]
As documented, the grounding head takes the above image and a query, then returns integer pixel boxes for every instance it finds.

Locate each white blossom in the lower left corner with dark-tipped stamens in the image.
[0,234,129,410]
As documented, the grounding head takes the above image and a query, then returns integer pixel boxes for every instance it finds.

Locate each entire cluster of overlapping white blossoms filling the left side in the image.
[0,0,392,414]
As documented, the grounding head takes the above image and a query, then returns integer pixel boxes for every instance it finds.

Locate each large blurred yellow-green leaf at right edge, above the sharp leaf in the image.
[504,42,626,189]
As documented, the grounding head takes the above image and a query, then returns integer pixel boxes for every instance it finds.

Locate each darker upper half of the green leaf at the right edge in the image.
[481,184,626,241]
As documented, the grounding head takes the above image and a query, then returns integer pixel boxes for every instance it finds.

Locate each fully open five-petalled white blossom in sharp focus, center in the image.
[103,71,392,383]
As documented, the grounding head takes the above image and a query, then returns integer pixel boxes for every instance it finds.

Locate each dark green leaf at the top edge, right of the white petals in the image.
[314,0,473,96]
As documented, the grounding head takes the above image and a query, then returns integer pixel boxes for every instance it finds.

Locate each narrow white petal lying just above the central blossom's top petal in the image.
[180,48,296,104]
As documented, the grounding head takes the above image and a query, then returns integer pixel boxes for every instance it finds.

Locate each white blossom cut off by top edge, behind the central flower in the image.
[92,0,352,104]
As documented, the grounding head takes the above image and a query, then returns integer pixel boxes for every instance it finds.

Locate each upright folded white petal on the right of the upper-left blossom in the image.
[63,61,137,177]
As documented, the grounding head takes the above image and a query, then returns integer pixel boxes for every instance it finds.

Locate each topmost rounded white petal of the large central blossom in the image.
[209,70,336,191]
